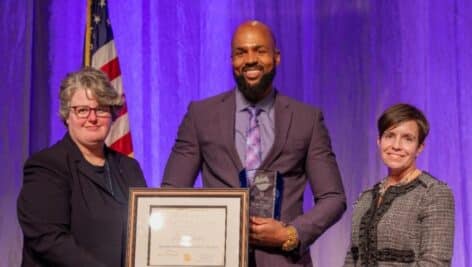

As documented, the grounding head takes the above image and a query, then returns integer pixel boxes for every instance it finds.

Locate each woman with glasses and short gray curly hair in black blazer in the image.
[18,68,146,267]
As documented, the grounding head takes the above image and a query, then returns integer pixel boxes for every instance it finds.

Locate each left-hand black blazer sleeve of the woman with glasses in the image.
[17,157,105,267]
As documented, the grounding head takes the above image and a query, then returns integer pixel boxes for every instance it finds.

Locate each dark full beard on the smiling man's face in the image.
[233,66,276,103]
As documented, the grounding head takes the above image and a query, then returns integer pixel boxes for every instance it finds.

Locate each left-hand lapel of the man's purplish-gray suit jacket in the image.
[219,89,243,173]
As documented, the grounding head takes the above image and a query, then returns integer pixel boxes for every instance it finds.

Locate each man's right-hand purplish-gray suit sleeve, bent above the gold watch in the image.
[291,111,346,253]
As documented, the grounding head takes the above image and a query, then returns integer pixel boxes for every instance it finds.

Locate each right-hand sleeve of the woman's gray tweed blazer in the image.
[418,183,454,266]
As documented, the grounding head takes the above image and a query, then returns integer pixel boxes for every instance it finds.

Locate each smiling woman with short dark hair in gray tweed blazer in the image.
[344,104,454,267]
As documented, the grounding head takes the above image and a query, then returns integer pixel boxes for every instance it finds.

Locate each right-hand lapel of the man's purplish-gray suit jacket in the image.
[260,92,292,169]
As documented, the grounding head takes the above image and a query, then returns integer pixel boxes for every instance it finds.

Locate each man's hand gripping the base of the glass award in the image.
[249,217,288,247]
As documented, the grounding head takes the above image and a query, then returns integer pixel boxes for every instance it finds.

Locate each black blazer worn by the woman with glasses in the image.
[18,134,146,267]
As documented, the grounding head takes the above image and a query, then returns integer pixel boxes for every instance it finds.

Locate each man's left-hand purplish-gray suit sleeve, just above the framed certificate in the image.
[161,103,201,187]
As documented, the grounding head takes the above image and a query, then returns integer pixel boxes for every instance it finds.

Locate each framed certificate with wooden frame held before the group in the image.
[126,188,249,267]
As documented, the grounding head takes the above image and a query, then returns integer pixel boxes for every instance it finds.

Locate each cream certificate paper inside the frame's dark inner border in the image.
[148,206,227,266]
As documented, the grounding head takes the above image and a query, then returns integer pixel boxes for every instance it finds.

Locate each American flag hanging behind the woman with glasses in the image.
[84,0,133,156]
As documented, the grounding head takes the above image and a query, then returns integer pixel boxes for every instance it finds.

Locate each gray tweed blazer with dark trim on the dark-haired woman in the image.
[344,172,454,266]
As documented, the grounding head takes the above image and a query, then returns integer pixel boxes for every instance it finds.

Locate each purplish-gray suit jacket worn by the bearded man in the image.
[162,90,346,267]
